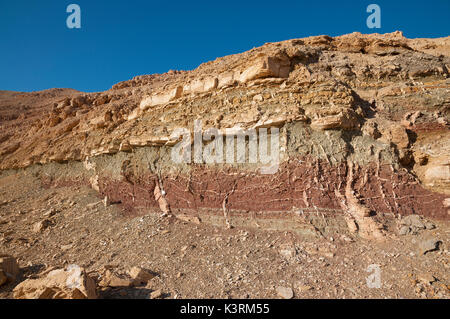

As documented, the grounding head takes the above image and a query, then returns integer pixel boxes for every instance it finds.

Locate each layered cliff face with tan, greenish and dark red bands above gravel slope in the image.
[0,32,450,237]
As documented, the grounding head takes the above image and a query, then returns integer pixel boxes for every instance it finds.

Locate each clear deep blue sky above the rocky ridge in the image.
[0,0,450,92]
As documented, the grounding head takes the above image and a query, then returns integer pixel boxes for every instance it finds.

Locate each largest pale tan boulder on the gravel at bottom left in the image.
[13,265,97,299]
